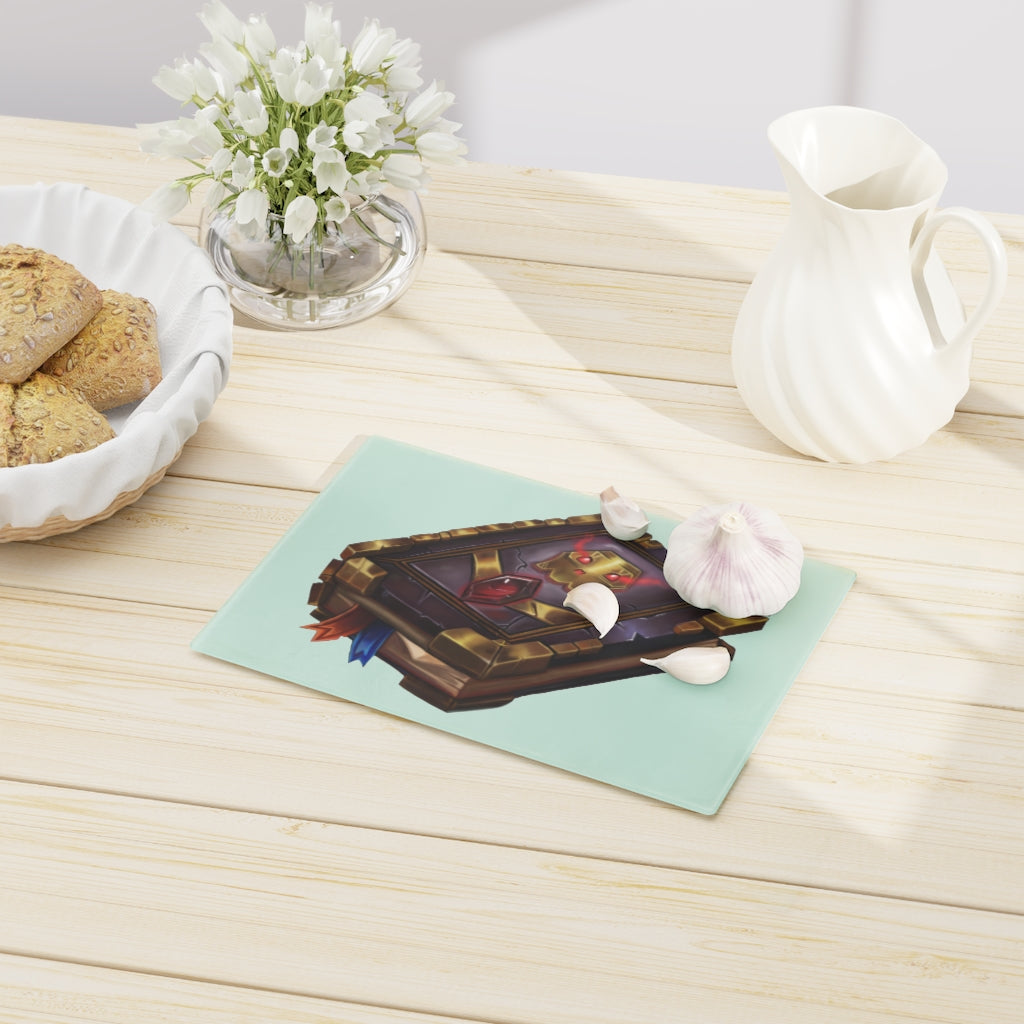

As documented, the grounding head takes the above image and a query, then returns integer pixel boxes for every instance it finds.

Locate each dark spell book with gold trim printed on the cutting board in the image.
[304,515,767,711]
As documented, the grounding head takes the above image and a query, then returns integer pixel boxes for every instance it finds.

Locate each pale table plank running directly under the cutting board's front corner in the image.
[0,592,1024,912]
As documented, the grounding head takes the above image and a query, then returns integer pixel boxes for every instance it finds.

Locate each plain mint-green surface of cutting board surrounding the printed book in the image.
[193,437,854,814]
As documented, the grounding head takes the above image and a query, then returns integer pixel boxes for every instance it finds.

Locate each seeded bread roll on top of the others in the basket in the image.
[0,245,103,384]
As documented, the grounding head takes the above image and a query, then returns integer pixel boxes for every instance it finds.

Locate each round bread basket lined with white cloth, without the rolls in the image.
[0,184,232,543]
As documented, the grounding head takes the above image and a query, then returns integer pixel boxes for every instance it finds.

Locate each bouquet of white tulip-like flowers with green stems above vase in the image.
[139,0,466,245]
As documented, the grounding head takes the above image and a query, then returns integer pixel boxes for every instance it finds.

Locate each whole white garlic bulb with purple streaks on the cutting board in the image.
[665,502,804,618]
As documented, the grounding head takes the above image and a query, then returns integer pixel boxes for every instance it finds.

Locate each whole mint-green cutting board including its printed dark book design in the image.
[193,437,853,814]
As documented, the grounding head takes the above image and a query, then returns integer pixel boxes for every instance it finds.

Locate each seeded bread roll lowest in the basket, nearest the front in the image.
[0,373,115,466]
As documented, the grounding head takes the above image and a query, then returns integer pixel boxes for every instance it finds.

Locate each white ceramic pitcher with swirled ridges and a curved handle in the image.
[732,106,1007,463]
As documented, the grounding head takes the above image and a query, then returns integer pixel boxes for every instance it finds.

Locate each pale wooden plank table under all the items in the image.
[0,119,1024,1024]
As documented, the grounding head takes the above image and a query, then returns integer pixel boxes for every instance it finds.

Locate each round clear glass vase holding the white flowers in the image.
[202,191,427,330]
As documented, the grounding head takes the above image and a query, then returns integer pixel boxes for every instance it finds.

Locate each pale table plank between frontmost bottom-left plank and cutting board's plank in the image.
[6,783,1024,1024]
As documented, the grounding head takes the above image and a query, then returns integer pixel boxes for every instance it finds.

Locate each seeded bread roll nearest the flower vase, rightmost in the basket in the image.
[39,289,161,412]
